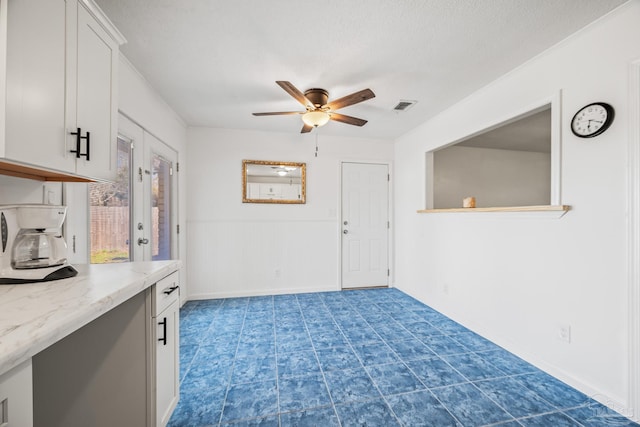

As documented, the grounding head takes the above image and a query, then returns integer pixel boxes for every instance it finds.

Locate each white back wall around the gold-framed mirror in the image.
[187,128,393,299]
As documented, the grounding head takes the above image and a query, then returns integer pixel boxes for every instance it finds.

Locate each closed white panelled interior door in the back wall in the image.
[341,163,389,289]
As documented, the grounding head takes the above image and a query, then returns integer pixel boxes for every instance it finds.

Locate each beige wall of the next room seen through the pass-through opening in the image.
[427,146,551,209]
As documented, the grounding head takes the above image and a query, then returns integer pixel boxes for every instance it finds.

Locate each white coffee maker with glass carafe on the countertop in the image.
[0,204,78,284]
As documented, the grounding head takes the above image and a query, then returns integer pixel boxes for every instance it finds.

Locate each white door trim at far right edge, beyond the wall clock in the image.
[627,59,640,421]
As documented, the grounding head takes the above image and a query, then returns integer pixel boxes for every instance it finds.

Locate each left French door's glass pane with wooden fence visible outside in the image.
[89,137,132,264]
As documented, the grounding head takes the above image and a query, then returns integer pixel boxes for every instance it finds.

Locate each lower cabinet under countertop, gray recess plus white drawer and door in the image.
[31,272,179,427]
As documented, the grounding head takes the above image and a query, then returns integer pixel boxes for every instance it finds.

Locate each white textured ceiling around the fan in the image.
[96,0,625,139]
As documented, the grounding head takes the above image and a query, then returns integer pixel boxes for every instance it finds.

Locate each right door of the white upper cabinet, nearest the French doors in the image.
[67,3,118,180]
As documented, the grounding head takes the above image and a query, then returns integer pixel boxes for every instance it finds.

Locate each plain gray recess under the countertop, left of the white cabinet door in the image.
[32,290,152,427]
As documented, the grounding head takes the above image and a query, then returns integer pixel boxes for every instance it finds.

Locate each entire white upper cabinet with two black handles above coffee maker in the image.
[0,0,124,180]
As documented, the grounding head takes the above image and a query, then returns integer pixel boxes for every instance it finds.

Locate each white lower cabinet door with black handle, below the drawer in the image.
[156,299,180,426]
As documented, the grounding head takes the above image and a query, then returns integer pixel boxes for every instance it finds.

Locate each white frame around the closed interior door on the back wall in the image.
[336,160,395,290]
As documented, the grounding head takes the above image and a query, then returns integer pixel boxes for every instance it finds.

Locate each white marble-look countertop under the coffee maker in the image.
[0,261,181,375]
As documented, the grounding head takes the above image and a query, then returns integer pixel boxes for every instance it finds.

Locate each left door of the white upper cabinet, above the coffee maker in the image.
[0,0,75,172]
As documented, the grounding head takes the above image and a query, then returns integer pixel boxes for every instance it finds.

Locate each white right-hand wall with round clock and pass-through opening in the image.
[394,1,640,416]
